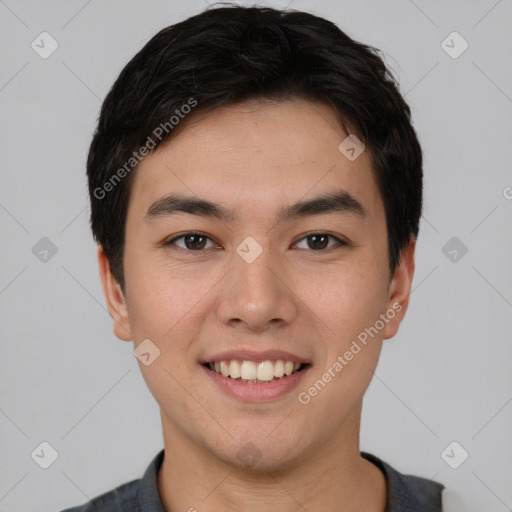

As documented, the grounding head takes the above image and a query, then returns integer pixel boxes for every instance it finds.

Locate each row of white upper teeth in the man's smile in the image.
[208,359,302,382]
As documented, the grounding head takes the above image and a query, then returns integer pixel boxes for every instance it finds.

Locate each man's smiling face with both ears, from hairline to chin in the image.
[99,100,414,469]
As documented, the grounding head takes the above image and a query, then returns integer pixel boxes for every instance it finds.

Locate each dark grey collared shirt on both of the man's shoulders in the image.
[62,450,444,512]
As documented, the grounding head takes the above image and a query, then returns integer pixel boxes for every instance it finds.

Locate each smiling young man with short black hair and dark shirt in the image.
[61,7,443,512]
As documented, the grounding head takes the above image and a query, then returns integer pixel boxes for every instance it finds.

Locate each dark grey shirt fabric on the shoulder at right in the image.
[361,452,444,512]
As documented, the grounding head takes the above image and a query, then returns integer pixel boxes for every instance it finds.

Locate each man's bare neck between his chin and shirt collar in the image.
[158,408,386,512]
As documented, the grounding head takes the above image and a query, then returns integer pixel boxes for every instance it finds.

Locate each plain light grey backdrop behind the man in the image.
[0,0,512,512]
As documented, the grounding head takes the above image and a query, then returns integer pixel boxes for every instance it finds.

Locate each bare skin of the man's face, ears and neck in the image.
[98,100,415,512]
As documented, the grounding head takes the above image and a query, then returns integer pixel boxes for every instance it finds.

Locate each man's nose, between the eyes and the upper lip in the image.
[217,242,299,332]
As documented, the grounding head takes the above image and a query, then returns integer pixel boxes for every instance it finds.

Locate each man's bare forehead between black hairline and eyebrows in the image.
[129,100,382,226]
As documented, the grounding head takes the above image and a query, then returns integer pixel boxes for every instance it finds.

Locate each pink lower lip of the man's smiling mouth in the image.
[201,365,310,402]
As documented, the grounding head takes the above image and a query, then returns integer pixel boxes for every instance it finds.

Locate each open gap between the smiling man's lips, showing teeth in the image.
[202,359,311,384]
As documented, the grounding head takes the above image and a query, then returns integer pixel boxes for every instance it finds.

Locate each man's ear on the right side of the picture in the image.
[383,235,416,339]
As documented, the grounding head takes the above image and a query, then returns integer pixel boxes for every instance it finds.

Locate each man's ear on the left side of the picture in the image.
[98,245,132,341]
